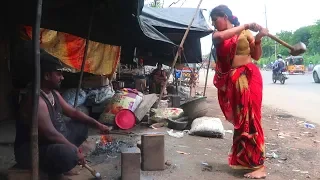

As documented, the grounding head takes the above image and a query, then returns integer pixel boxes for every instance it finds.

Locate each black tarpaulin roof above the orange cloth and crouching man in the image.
[6,0,144,45]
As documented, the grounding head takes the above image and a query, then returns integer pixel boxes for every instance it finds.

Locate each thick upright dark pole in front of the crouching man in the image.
[30,0,42,180]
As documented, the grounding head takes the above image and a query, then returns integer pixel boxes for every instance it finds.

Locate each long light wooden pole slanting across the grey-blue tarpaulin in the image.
[156,0,203,107]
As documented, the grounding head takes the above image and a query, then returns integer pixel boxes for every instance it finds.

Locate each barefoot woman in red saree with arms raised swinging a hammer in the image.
[210,5,268,179]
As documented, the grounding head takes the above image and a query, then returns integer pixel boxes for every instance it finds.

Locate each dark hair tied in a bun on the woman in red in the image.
[210,5,240,26]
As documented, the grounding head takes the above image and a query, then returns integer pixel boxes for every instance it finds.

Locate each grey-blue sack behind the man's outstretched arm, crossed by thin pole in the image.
[62,88,87,107]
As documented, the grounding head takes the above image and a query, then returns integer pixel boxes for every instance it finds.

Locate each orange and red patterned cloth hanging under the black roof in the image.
[22,26,121,76]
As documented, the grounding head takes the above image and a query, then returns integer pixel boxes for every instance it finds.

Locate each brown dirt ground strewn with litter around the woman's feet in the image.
[0,87,320,180]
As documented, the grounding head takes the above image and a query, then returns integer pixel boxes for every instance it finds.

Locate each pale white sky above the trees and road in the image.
[144,0,320,54]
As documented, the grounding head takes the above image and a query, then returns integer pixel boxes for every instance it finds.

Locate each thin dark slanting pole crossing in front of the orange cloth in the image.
[73,1,95,107]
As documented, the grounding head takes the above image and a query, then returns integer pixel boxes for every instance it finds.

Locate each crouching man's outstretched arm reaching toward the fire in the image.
[55,91,102,128]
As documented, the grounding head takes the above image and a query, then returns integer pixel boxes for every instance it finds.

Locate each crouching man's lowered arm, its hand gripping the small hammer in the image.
[38,98,77,149]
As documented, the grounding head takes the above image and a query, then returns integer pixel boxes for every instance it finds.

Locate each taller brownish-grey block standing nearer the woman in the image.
[141,134,165,171]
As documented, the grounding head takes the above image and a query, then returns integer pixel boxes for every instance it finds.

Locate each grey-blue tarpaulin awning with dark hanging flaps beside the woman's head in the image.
[135,6,212,65]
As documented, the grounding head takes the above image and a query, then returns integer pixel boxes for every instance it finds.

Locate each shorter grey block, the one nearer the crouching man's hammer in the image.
[121,148,141,180]
